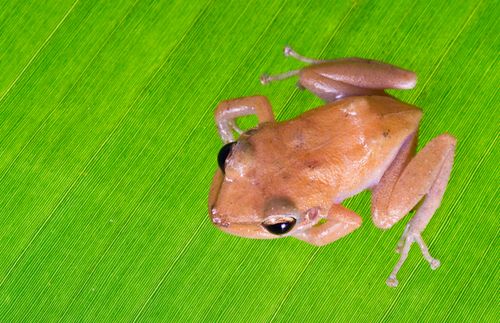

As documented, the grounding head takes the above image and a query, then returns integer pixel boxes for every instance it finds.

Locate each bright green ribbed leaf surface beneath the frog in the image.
[0,0,500,322]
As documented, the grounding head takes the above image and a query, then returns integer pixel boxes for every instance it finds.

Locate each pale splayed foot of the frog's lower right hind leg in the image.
[386,228,441,287]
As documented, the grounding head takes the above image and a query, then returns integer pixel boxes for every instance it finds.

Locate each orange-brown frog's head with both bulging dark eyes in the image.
[209,134,320,239]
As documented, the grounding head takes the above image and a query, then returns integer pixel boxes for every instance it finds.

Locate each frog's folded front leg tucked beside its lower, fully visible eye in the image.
[294,204,362,246]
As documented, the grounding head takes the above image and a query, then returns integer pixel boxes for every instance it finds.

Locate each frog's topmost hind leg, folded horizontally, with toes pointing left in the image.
[261,47,417,102]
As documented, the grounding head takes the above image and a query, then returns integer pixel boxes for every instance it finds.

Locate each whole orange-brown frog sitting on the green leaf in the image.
[208,46,456,287]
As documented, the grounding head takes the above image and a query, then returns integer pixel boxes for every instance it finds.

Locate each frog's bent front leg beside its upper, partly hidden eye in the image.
[215,95,274,143]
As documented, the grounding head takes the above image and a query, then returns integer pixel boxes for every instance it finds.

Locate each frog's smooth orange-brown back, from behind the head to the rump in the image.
[250,96,422,206]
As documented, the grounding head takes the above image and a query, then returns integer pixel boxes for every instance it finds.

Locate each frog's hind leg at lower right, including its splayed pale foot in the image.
[372,134,456,287]
